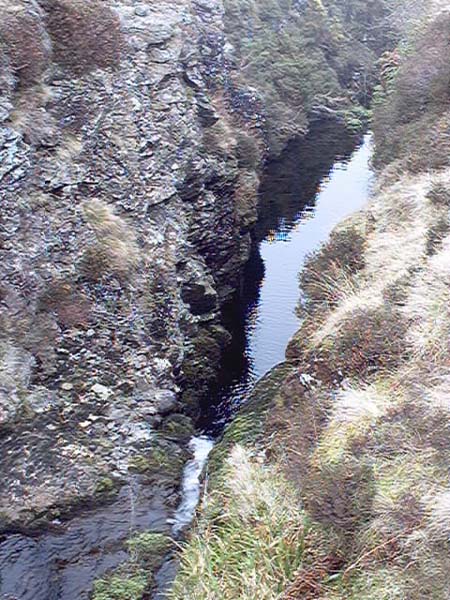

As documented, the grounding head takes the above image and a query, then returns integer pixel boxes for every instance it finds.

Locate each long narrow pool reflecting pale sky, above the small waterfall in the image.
[200,124,371,435]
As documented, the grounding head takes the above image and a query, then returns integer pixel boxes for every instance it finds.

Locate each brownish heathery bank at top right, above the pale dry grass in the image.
[374,3,450,172]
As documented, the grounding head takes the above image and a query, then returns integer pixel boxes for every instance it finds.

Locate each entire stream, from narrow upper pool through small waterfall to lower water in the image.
[0,120,371,600]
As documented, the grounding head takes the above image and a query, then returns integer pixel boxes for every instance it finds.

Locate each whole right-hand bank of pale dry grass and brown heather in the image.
[172,5,450,600]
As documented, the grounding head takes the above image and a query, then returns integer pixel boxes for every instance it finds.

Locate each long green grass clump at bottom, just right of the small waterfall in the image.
[171,445,308,600]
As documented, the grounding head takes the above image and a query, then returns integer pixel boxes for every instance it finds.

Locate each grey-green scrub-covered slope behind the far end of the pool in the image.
[225,0,397,153]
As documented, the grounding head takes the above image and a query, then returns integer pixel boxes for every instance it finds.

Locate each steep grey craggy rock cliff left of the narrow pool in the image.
[0,0,259,524]
